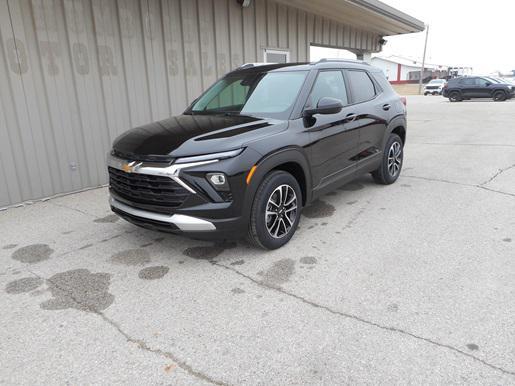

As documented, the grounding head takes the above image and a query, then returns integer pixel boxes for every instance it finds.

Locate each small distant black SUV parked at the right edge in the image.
[443,76,515,102]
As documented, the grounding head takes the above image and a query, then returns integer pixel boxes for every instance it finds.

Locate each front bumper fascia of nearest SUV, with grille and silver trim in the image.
[107,152,255,240]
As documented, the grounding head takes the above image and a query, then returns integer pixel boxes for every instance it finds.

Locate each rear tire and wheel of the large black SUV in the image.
[372,134,404,185]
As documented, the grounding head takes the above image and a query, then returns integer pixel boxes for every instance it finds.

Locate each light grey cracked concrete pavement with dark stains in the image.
[0,96,515,385]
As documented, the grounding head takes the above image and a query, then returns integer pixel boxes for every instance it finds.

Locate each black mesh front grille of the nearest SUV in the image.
[108,167,190,208]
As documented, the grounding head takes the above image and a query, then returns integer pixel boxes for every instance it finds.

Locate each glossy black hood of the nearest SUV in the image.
[113,114,288,159]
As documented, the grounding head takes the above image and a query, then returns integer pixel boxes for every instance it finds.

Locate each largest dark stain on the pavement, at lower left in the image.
[40,269,114,312]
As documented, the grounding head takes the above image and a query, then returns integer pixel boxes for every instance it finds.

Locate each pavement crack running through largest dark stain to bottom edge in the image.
[27,268,229,386]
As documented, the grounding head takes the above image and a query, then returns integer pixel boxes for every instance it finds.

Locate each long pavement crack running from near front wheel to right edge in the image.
[211,261,515,376]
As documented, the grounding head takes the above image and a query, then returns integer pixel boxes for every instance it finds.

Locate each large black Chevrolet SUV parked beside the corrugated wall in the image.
[108,60,406,249]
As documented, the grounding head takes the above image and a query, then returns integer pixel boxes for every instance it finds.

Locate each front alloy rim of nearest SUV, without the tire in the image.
[265,185,297,239]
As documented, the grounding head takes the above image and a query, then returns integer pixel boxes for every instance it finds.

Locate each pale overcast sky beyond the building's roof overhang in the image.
[382,0,515,73]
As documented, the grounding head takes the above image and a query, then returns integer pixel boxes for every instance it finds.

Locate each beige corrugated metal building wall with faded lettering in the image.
[0,0,379,207]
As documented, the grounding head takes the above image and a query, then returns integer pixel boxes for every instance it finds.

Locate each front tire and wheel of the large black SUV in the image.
[248,170,302,249]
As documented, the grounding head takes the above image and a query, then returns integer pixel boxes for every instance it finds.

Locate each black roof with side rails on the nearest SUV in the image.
[227,59,381,75]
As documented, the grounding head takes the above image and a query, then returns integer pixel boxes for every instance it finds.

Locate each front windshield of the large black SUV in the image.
[191,71,307,119]
